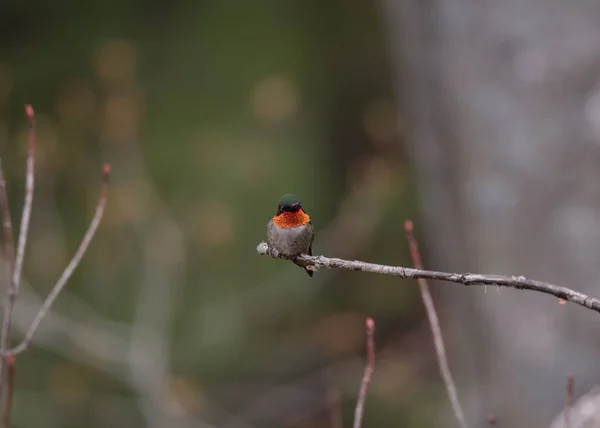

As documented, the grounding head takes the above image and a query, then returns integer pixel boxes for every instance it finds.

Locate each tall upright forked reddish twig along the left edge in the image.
[0,105,35,398]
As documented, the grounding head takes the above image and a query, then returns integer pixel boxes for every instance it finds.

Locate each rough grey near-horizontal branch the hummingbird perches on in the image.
[256,242,600,313]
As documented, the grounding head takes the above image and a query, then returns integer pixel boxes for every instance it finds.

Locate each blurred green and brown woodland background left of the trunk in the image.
[0,0,445,428]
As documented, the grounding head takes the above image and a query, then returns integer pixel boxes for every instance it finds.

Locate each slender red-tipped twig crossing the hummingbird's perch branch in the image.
[404,220,467,428]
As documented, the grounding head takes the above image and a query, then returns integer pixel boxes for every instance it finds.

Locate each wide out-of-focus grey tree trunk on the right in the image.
[382,0,600,427]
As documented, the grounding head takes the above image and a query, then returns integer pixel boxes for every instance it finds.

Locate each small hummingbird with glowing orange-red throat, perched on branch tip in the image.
[267,193,315,278]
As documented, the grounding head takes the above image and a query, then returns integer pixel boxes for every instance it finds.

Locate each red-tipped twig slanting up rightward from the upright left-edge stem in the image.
[4,164,110,355]
